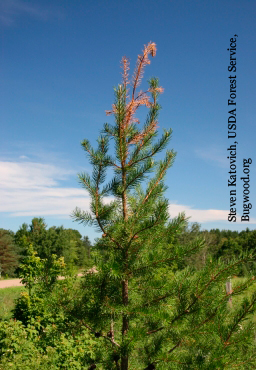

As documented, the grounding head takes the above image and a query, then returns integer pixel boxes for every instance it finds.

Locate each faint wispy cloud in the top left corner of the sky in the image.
[0,0,63,27]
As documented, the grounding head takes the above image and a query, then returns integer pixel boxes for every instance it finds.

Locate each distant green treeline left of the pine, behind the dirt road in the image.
[0,218,91,277]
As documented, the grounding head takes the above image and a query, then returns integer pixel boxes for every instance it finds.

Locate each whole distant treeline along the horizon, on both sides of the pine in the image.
[0,218,256,277]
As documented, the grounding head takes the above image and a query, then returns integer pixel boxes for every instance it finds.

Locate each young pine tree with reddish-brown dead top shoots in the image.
[73,42,255,370]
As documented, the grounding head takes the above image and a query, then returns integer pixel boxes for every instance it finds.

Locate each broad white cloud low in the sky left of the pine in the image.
[0,161,89,218]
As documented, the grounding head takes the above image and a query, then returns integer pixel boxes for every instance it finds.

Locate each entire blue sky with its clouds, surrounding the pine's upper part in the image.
[0,0,256,240]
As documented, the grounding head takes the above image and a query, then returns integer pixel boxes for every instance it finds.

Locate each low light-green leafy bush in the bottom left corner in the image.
[0,320,103,370]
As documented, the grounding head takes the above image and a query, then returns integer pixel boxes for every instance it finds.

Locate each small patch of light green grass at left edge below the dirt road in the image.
[0,286,25,320]
